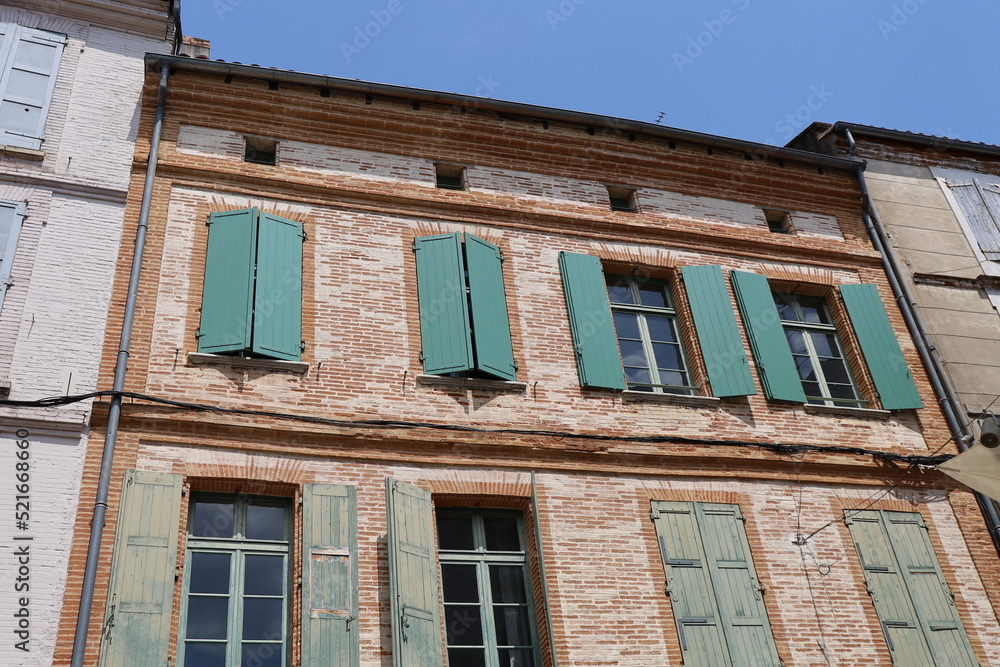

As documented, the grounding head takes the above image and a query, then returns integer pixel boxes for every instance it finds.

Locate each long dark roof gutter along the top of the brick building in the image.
[146,53,857,172]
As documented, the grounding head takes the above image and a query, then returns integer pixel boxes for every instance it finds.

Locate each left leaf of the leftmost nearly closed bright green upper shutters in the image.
[198,208,257,352]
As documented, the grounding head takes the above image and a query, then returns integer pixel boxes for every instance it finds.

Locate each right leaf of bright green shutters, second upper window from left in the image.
[465,234,517,380]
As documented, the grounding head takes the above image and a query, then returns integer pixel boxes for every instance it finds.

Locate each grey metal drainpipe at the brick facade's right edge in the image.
[844,128,1000,555]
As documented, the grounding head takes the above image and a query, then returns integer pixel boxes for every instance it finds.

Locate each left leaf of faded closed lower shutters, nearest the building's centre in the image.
[652,501,736,667]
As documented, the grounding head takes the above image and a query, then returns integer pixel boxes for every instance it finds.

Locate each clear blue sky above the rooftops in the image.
[181,0,1000,145]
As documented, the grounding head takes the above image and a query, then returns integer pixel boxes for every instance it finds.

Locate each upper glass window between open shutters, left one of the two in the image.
[605,275,694,395]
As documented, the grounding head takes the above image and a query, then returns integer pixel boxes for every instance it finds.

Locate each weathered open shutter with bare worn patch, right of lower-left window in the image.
[302,484,361,667]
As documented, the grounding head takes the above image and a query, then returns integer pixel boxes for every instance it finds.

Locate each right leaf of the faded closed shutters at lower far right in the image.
[881,512,979,667]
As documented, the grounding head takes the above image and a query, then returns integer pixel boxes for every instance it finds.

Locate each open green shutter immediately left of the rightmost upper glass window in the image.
[729,271,806,403]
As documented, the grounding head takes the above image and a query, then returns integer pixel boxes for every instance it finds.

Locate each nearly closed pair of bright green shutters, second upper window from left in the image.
[413,232,517,380]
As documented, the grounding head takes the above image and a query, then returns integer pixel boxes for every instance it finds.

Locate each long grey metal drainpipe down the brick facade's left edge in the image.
[70,62,170,667]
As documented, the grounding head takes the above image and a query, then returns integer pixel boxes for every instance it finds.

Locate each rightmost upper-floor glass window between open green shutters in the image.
[774,294,865,406]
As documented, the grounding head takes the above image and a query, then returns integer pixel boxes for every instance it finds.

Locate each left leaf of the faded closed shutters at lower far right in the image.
[844,510,936,667]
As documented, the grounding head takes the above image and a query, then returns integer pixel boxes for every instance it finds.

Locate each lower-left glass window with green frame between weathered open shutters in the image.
[178,495,291,667]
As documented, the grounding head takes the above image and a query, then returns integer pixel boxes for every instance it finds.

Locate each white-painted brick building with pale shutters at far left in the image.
[0,0,175,666]
